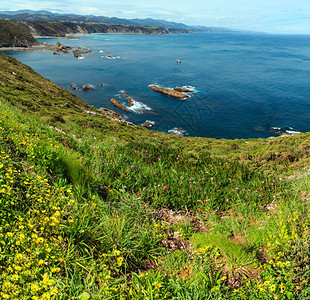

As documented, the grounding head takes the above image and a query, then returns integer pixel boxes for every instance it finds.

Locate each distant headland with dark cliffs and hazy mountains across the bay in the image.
[0,10,237,48]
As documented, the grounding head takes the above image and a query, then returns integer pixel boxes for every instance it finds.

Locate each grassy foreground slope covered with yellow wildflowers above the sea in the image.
[0,49,310,299]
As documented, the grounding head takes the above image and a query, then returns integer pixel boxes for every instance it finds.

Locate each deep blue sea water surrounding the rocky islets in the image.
[7,33,310,139]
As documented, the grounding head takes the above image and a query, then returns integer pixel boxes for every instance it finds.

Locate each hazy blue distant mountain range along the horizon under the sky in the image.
[0,10,235,32]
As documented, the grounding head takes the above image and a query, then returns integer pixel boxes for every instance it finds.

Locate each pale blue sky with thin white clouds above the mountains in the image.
[0,0,310,34]
